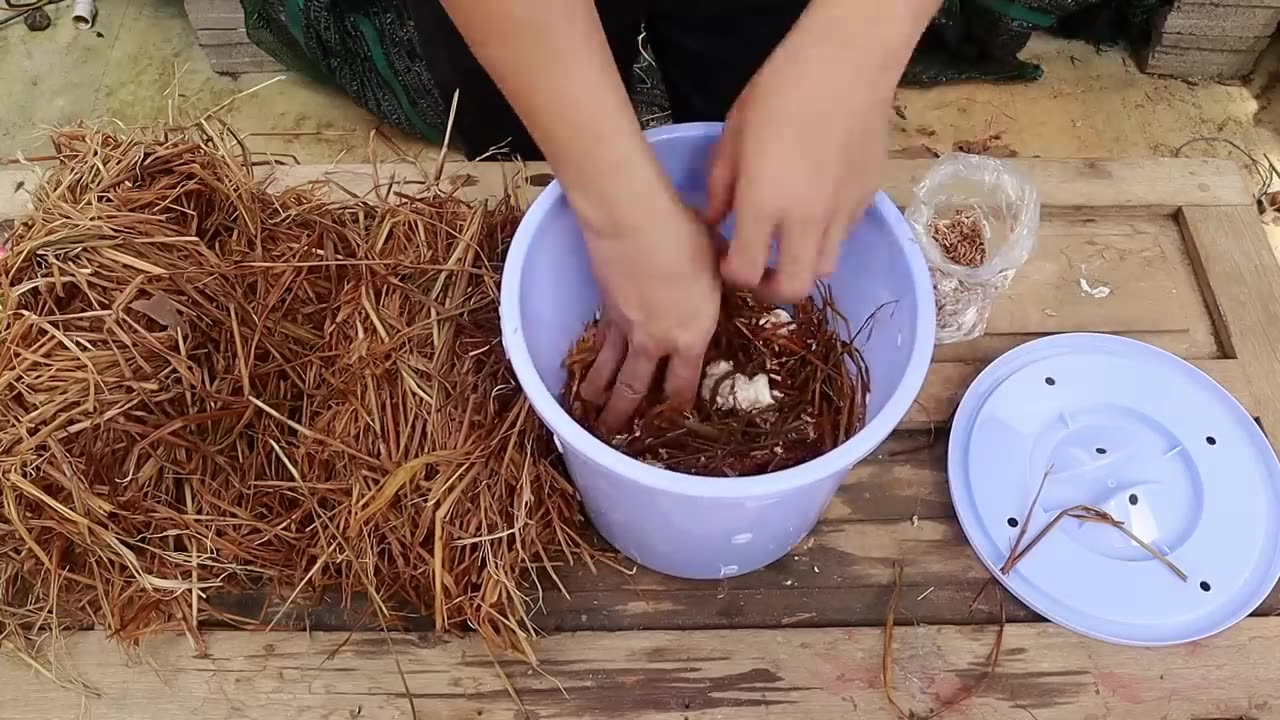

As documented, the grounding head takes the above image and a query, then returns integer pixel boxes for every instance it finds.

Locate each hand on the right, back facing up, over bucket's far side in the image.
[708,4,901,302]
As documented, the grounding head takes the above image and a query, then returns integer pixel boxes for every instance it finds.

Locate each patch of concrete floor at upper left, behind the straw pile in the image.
[0,0,409,163]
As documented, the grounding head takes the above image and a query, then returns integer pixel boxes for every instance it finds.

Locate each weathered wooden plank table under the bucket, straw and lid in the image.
[0,160,1280,720]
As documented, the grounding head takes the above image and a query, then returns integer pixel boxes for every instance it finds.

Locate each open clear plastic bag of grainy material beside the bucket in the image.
[906,152,1039,345]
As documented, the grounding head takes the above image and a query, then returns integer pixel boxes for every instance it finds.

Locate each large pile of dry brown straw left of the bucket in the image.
[0,123,591,657]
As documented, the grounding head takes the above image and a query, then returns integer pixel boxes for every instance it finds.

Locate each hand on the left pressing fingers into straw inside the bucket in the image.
[581,199,721,433]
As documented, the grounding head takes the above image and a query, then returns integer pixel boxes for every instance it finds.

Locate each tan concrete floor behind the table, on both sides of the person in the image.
[0,0,1280,190]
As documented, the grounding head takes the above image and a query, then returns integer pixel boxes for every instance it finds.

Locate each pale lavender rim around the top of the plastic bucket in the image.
[499,123,936,498]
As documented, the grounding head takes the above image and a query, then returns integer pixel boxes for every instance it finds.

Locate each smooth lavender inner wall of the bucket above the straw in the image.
[520,136,920,450]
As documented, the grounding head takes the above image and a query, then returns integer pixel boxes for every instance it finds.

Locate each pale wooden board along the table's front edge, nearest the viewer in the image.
[15,619,1280,720]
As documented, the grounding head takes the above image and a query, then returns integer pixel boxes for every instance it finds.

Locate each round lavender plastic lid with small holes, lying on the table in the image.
[947,334,1280,646]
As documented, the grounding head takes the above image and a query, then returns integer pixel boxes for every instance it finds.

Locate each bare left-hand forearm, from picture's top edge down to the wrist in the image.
[442,0,669,234]
